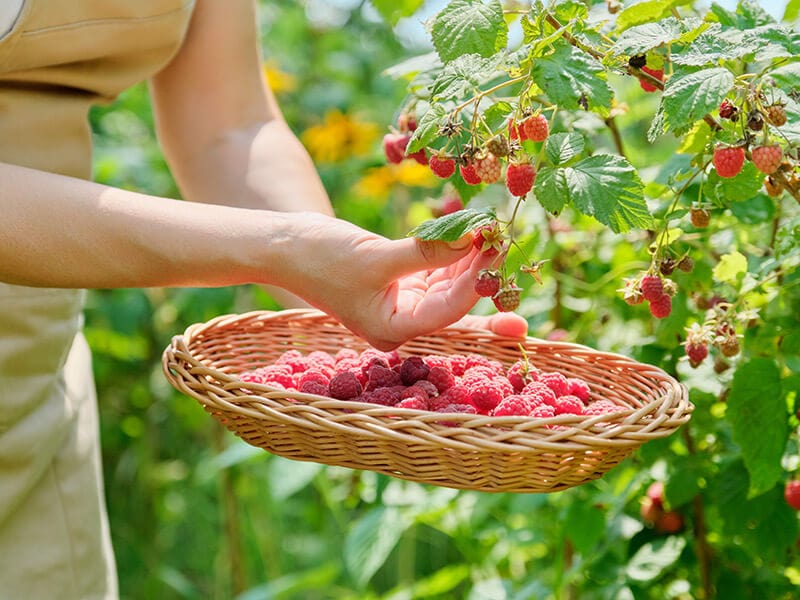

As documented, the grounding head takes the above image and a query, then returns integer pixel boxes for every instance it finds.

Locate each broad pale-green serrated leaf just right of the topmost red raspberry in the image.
[661,67,733,134]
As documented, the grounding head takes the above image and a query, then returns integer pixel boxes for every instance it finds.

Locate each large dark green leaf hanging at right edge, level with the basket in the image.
[725,358,789,497]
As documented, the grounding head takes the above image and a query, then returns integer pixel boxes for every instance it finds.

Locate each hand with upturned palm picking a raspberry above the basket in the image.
[272,213,504,350]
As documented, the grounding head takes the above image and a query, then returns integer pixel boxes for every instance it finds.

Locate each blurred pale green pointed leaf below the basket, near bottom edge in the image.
[344,506,408,588]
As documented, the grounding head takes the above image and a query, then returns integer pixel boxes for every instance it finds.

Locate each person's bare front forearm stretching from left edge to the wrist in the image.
[0,164,288,288]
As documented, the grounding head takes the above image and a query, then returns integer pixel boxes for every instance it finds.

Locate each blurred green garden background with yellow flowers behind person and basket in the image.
[86,0,800,600]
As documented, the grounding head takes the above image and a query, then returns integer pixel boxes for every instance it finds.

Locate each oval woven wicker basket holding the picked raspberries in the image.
[163,310,693,492]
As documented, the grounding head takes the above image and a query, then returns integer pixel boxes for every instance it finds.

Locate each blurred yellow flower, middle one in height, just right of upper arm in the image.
[301,110,378,162]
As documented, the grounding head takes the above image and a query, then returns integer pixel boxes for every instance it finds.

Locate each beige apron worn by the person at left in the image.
[0,0,194,600]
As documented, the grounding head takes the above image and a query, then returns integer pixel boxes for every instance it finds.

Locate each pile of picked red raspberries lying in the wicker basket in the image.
[239,348,624,418]
